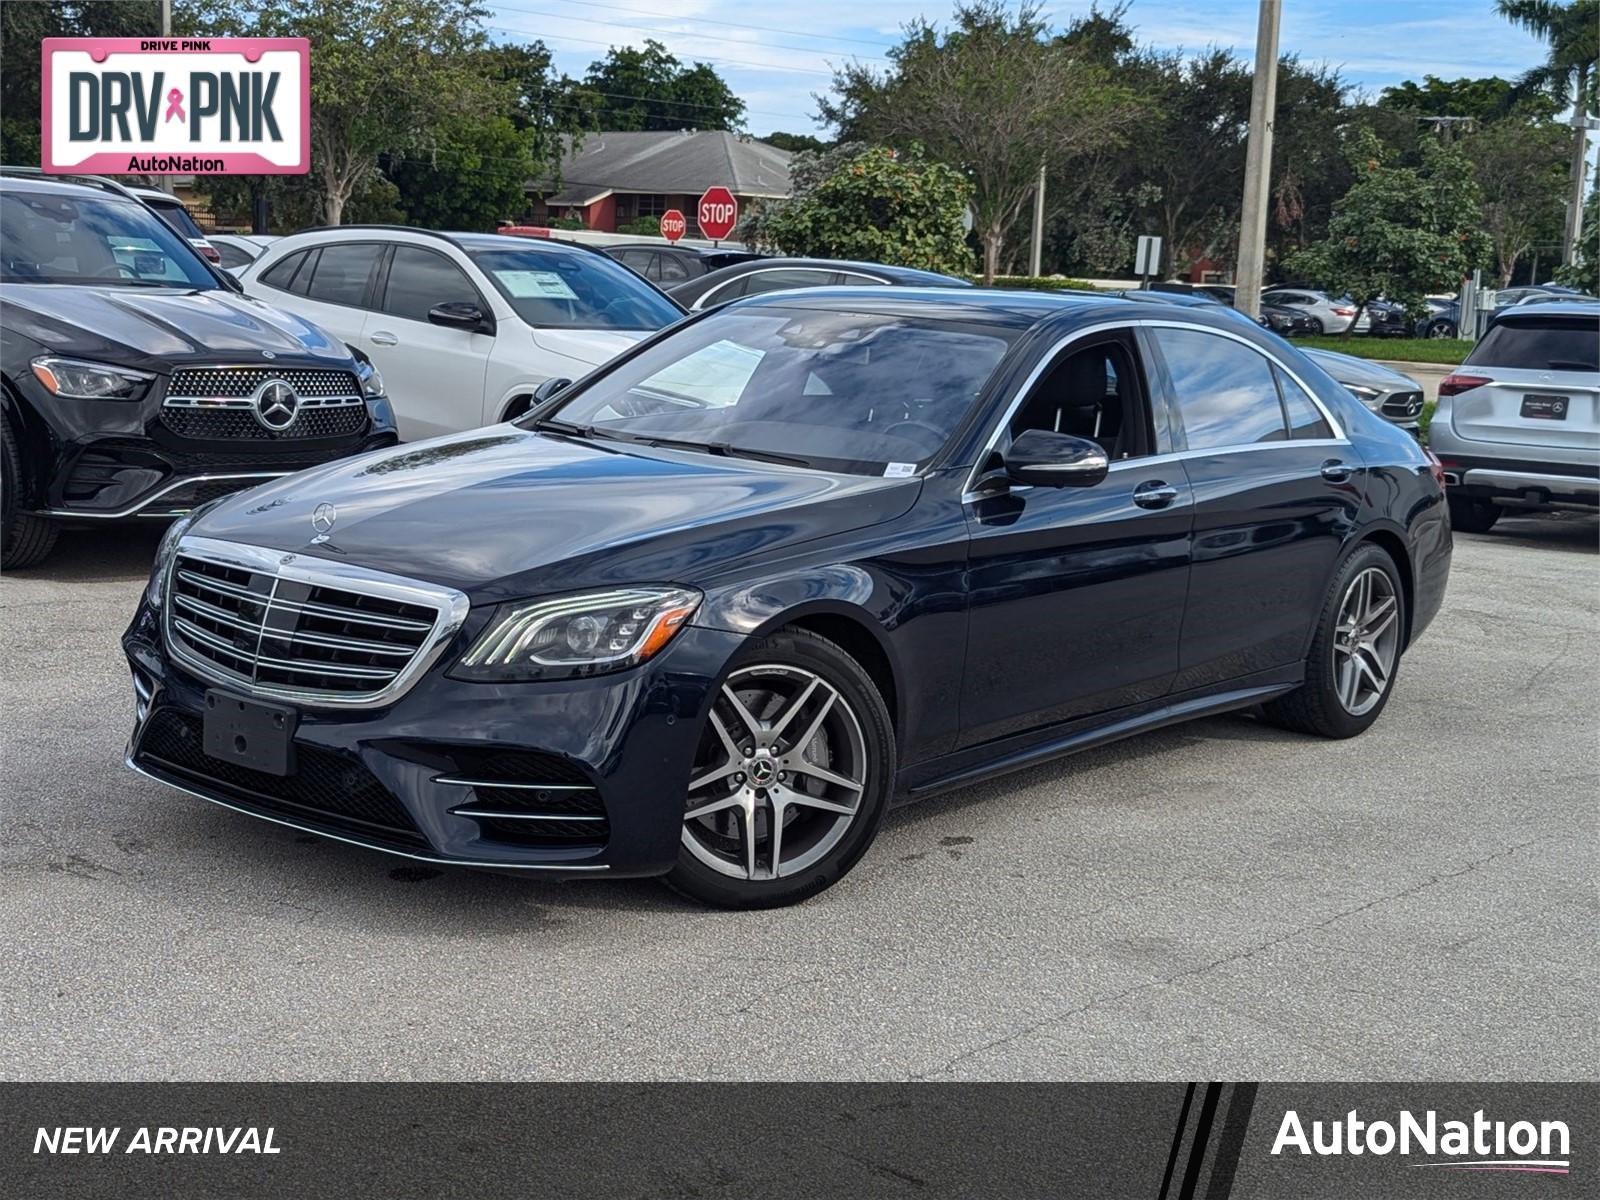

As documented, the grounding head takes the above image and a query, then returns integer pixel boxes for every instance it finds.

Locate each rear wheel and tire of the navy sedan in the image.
[1262,542,1406,738]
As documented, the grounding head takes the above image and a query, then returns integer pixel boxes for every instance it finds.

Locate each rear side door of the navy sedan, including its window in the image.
[1147,325,1362,693]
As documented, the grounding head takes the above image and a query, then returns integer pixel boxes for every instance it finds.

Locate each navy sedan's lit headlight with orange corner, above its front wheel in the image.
[454,587,701,682]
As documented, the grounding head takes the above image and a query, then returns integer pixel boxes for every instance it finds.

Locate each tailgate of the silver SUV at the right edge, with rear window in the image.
[1450,312,1600,451]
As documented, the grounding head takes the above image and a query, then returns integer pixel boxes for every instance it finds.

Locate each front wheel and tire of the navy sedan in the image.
[666,629,894,909]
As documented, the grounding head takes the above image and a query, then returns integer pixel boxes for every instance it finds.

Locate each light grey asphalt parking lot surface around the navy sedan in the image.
[0,517,1600,1080]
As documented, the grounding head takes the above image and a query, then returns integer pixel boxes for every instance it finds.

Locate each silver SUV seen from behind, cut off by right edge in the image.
[1429,302,1600,533]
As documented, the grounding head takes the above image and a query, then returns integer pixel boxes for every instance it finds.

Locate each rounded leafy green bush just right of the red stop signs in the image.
[758,146,973,274]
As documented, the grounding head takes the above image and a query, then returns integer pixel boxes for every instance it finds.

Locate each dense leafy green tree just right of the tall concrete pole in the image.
[1286,128,1488,336]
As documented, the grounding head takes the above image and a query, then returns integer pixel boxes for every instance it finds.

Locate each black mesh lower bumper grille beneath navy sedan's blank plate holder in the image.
[134,709,427,846]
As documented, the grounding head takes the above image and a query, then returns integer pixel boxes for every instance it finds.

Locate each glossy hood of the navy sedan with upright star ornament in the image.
[190,424,922,603]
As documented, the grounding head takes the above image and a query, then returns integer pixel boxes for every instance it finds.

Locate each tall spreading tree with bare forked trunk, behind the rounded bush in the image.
[818,0,1138,282]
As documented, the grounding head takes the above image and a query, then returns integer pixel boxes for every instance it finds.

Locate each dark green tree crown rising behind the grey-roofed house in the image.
[574,38,744,131]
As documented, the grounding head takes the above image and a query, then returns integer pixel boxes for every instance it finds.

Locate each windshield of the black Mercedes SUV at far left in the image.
[0,192,221,290]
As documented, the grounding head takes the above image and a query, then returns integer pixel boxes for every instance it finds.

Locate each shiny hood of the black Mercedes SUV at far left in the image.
[3,283,350,373]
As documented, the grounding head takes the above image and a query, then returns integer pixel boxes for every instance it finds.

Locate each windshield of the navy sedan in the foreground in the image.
[541,306,1016,475]
